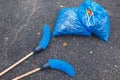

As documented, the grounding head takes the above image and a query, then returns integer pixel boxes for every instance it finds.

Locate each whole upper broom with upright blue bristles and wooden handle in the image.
[0,24,50,76]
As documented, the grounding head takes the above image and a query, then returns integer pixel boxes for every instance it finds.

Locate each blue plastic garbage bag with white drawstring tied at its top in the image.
[79,0,110,41]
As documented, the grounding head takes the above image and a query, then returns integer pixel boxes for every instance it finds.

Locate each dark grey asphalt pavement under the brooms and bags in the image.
[0,0,120,80]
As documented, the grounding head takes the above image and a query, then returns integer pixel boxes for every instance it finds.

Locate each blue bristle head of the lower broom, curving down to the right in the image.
[48,59,75,77]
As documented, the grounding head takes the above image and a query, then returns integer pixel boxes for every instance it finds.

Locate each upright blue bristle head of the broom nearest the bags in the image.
[39,24,50,49]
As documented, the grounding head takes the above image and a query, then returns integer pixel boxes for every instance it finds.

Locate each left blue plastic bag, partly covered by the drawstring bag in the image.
[52,7,91,37]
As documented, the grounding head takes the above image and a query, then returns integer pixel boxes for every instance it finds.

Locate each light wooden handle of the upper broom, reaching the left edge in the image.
[0,52,34,76]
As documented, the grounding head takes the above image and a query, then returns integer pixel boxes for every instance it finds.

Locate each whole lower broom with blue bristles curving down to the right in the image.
[12,59,75,80]
